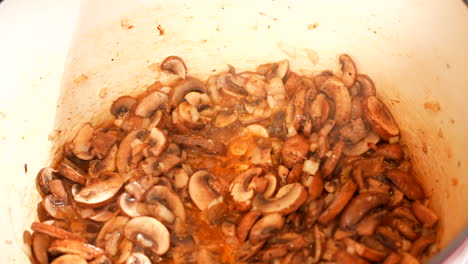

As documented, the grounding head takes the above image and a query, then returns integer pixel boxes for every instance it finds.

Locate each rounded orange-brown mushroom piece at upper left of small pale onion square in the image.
[281,135,309,168]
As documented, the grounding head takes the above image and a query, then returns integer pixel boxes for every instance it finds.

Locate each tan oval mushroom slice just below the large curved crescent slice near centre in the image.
[249,213,285,245]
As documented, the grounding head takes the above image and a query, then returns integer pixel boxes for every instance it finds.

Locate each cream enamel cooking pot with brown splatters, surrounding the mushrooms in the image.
[0,0,468,263]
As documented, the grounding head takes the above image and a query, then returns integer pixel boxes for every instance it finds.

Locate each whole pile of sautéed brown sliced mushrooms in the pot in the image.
[30,54,438,264]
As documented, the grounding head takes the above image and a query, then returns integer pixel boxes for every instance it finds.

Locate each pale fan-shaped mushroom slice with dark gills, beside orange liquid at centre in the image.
[189,170,223,211]
